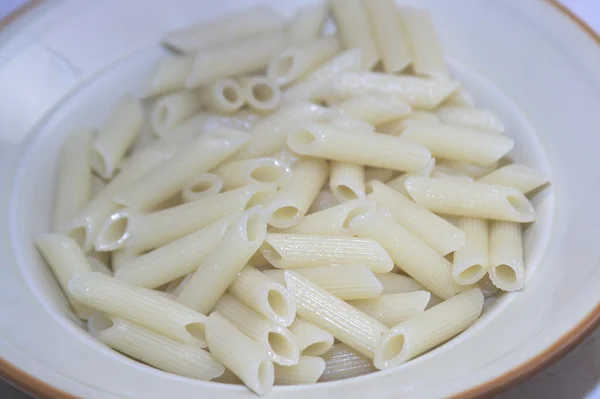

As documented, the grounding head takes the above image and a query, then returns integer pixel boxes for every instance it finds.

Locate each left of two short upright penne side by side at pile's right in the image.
[452,217,489,285]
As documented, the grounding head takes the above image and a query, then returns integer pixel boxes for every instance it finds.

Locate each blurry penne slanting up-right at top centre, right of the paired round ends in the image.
[283,48,362,103]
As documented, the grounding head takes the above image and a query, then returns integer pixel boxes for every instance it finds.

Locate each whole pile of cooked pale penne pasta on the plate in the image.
[36,0,548,395]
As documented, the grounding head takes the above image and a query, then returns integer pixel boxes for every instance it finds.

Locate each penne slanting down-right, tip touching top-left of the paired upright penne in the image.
[367,181,465,255]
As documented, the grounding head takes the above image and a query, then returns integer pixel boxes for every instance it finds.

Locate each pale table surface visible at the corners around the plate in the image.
[0,0,600,399]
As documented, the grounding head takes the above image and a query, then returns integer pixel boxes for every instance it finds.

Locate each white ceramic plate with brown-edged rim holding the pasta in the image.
[0,0,600,399]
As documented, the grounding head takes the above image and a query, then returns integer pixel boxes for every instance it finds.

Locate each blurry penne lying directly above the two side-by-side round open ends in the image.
[185,31,286,88]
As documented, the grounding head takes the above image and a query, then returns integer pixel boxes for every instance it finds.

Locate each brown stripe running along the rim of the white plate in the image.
[0,0,600,399]
